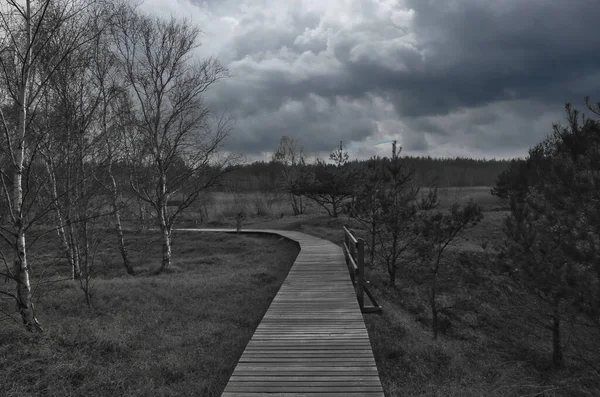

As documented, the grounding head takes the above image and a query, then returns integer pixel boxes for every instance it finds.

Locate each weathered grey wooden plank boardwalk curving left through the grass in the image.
[182,229,383,397]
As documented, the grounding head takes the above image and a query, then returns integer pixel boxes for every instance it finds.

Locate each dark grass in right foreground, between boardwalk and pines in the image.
[365,248,600,396]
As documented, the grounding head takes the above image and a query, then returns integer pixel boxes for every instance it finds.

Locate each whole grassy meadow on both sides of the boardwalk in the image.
[0,187,600,397]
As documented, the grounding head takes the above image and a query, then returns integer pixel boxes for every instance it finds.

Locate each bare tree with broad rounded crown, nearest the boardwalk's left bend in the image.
[113,8,232,271]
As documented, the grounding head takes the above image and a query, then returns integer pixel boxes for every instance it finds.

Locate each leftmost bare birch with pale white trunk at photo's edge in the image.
[0,0,91,331]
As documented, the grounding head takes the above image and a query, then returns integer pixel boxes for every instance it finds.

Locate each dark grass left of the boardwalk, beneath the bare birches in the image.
[0,232,298,397]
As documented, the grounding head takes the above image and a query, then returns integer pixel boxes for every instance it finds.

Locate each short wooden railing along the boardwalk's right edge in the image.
[344,226,381,313]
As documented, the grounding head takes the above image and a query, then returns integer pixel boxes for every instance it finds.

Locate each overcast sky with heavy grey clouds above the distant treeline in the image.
[142,0,600,160]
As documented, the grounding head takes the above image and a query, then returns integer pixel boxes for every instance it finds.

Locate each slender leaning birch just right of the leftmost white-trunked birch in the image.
[39,17,102,279]
